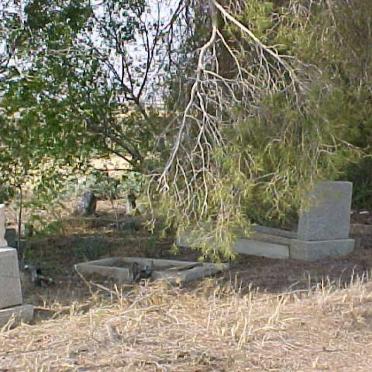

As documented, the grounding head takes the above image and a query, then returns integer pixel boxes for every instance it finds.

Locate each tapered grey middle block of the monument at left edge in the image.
[0,248,22,309]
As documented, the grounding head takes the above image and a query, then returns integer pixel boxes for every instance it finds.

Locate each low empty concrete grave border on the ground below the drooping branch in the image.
[75,257,229,284]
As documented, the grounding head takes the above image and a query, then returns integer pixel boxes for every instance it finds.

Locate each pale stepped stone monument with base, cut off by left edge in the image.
[0,204,33,327]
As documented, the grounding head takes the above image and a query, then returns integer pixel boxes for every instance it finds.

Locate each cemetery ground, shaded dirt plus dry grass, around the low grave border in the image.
[0,202,372,371]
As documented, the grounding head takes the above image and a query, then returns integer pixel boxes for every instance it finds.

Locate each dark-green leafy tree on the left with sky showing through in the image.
[0,0,185,201]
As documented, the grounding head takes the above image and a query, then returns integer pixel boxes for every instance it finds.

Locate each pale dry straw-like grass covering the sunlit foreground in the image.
[0,278,372,371]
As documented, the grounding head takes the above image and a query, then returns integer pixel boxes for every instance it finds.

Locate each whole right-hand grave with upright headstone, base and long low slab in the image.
[178,181,355,261]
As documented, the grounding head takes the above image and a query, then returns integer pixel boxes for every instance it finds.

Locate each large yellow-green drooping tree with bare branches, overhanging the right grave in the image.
[150,0,371,256]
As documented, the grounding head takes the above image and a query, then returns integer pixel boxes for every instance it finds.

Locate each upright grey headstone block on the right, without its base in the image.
[297,181,352,241]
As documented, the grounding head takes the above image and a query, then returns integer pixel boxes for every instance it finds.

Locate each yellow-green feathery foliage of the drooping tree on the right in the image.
[150,0,372,259]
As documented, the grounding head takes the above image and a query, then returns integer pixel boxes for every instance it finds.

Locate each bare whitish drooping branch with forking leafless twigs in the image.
[157,0,301,203]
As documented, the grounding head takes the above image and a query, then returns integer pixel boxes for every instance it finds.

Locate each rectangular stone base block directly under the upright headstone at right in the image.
[290,239,355,261]
